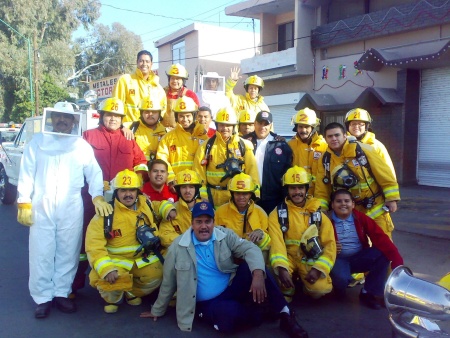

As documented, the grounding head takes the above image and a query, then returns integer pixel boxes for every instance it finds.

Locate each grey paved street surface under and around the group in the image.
[0,187,450,338]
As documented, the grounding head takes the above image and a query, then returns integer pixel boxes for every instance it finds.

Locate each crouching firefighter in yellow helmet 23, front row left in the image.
[86,169,171,313]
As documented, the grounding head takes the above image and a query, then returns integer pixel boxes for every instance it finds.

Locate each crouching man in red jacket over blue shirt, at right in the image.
[330,189,403,310]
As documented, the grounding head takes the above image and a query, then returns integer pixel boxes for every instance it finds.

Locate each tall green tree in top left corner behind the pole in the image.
[0,0,101,120]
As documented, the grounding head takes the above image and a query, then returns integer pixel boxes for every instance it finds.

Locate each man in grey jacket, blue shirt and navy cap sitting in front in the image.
[141,202,308,338]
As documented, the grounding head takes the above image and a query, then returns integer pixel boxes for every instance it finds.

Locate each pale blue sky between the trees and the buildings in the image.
[74,0,259,67]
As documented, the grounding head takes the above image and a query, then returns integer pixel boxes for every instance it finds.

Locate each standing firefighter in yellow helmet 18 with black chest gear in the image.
[193,107,259,208]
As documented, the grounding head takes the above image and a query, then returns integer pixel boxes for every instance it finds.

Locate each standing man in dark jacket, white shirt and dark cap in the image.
[244,111,292,214]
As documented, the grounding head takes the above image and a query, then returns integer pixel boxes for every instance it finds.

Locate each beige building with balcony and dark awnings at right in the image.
[225,0,450,187]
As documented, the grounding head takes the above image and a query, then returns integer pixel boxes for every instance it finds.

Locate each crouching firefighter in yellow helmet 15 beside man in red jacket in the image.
[269,166,336,298]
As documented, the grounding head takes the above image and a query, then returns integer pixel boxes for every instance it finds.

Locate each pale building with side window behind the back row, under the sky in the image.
[155,23,259,93]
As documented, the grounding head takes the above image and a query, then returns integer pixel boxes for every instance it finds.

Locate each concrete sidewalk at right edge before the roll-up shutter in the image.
[391,185,450,240]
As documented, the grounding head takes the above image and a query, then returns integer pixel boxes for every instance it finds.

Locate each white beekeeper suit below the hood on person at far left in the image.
[17,109,103,304]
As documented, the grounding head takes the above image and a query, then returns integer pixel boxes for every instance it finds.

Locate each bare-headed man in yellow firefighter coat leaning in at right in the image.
[315,123,400,239]
